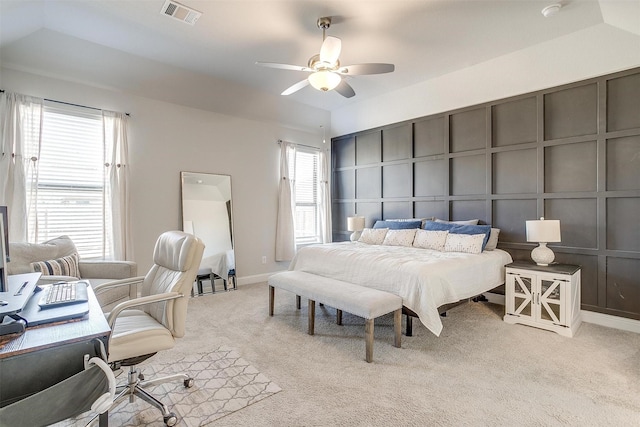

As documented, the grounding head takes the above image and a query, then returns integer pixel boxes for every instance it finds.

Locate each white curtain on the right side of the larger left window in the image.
[102,111,133,260]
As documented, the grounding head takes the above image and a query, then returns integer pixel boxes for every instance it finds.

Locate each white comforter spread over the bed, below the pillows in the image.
[289,242,512,336]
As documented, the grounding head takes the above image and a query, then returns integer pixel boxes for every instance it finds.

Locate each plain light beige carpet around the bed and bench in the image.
[184,283,640,427]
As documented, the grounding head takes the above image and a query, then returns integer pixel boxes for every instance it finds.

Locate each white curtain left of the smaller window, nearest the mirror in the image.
[276,141,296,261]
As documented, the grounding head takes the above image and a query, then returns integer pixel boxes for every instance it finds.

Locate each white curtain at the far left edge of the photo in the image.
[0,92,44,242]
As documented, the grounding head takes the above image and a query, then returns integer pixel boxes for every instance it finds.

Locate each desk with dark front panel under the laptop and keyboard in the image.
[0,287,111,407]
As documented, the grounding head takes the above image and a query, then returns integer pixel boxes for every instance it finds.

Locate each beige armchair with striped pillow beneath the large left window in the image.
[7,236,137,311]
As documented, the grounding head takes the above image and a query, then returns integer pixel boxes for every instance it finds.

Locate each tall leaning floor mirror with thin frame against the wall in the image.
[180,172,236,295]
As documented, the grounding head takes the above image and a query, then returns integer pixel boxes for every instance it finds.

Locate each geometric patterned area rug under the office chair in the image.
[56,346,281,427]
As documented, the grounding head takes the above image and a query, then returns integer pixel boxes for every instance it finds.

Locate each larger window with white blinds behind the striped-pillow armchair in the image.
[26,102,111,258]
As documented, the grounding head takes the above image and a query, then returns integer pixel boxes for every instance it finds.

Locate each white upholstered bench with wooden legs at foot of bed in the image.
[268,271,402,362]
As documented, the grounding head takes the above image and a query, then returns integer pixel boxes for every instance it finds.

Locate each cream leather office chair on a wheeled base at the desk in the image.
[94,231,204,426]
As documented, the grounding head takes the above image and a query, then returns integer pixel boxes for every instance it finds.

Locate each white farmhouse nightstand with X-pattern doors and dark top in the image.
[504,261,581,337]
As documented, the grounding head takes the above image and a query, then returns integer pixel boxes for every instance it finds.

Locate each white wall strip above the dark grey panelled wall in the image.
[331,24,640,136]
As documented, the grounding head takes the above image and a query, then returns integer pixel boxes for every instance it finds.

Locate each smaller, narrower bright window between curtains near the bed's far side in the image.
[289,146,322,245]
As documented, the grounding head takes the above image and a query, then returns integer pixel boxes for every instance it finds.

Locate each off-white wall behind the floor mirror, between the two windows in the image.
[0,68,328,283]
